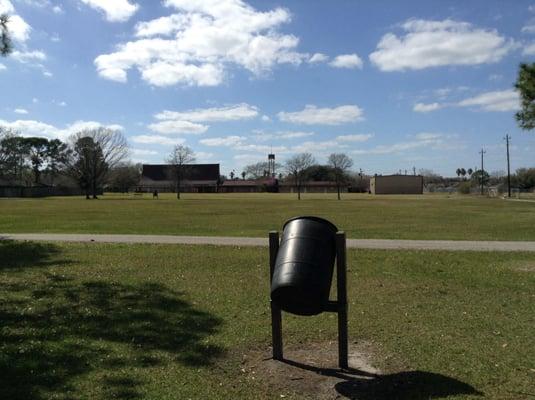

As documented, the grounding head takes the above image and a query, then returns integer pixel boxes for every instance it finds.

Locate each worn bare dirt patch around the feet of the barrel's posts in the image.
[242,342,380,400]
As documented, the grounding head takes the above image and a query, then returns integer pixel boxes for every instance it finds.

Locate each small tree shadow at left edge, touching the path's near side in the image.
[0,237,69,271]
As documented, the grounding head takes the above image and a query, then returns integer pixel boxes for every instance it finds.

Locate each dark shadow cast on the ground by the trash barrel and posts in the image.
[283,360,483,400]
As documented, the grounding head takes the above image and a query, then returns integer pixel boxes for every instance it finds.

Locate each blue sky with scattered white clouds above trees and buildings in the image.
[0,0,535,176]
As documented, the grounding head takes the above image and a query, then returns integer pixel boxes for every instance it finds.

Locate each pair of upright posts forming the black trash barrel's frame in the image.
[269,231,349,369]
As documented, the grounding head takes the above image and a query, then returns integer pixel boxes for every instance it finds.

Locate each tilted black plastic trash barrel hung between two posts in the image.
[271,217,338,315]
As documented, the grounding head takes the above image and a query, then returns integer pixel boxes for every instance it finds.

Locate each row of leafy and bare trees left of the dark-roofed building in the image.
[0,127,141,199]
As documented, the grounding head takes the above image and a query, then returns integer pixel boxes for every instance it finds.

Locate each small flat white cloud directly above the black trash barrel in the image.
[277,105,363,125]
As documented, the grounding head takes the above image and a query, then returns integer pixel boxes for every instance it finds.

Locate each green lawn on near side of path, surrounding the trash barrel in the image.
[0,239,535,400]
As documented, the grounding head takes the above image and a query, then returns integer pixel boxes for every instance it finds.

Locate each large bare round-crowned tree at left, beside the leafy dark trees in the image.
[68,127,128,199]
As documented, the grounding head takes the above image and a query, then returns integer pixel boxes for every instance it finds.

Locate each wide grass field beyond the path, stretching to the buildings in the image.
[0,193,535,240]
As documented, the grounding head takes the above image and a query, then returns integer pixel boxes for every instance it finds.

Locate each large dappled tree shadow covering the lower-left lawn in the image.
[0,244,223,400]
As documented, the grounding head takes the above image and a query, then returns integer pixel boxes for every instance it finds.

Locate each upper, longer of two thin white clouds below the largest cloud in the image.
[154,103,258,122]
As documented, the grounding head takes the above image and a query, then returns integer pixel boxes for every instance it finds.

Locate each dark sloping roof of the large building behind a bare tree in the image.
[141,164,219,181]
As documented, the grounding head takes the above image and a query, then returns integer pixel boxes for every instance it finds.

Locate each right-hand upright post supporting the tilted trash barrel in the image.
[336,232,349,369]
